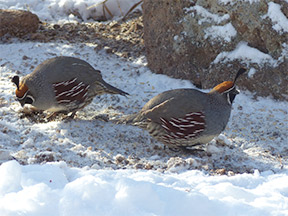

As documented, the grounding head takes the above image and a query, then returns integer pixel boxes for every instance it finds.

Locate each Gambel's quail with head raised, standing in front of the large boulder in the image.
[124,68,246,149]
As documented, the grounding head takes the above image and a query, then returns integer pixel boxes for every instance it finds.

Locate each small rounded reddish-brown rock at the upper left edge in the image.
[0,9,39,37]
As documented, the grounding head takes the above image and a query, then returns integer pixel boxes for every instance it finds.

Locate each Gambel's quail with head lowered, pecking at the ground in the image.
[12,56,128,116]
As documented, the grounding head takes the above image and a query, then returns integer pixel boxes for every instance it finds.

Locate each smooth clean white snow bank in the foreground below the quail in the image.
[0,161,288,216]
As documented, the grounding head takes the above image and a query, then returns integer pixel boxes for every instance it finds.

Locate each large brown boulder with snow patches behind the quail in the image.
[143,0,288,100]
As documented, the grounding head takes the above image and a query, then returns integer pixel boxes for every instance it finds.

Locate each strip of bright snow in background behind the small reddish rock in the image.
[0,0,141,23]
